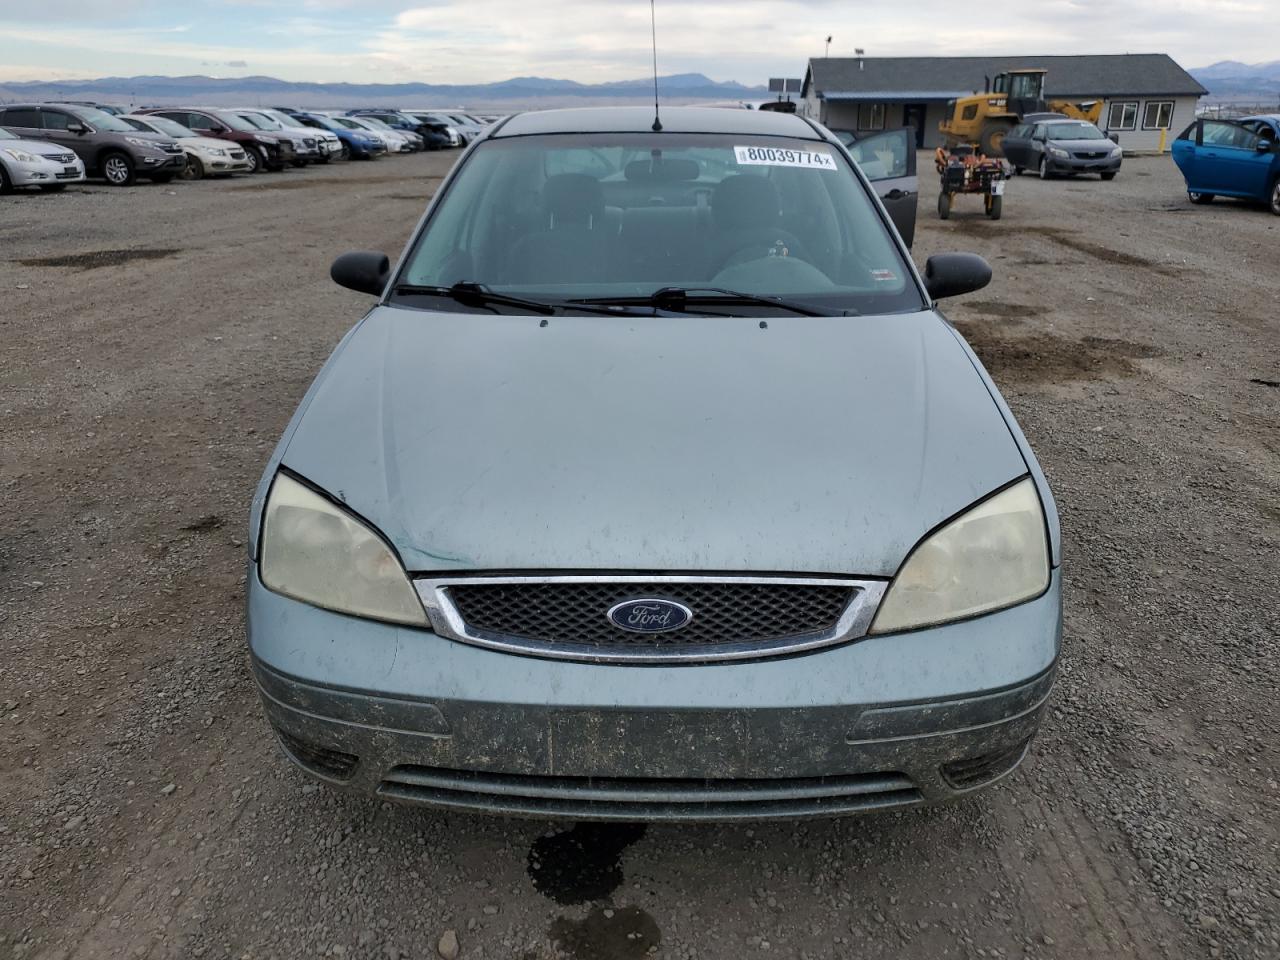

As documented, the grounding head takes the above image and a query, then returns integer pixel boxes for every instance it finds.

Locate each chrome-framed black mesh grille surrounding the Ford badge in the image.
[417,576,884,660]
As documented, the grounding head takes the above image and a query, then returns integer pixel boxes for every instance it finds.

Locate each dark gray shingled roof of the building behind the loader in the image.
[804,54,1208,99]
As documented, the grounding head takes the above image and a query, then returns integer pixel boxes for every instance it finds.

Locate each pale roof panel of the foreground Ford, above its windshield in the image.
[489,106,823,140]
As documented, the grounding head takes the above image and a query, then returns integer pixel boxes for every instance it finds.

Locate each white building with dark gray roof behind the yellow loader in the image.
[799,54,1208,151]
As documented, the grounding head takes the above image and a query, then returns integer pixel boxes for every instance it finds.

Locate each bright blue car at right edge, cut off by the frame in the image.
[1172,116,1280,216]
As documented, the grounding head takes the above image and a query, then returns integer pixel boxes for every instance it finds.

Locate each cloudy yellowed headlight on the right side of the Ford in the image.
[870,477,1050,634]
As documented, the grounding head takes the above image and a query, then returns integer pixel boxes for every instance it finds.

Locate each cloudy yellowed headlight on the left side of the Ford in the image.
[260,474,426,626]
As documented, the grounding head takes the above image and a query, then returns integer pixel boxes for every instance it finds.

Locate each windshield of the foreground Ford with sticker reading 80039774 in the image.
[398,133,922,314]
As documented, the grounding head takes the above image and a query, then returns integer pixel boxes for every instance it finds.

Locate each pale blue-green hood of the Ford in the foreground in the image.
[282,307,1028,576]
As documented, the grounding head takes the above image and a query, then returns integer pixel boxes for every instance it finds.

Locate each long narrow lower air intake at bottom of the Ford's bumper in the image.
[378,765,923,820]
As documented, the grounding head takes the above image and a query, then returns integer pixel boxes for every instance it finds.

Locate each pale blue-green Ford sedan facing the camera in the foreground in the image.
[247,108,1062,820]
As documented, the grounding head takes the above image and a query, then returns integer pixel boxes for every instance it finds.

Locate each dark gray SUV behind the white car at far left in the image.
[0,104,187,187]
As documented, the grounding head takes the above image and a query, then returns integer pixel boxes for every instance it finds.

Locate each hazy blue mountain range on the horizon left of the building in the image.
[0,73,768,110]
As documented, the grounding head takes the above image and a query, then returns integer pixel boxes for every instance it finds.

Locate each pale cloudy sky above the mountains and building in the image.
[0,0,1264,83]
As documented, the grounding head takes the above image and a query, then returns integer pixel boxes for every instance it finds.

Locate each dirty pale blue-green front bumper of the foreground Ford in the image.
[248,566,1061,820]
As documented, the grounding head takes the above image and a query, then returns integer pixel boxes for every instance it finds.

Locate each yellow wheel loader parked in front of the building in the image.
[938,68,1102,156]
